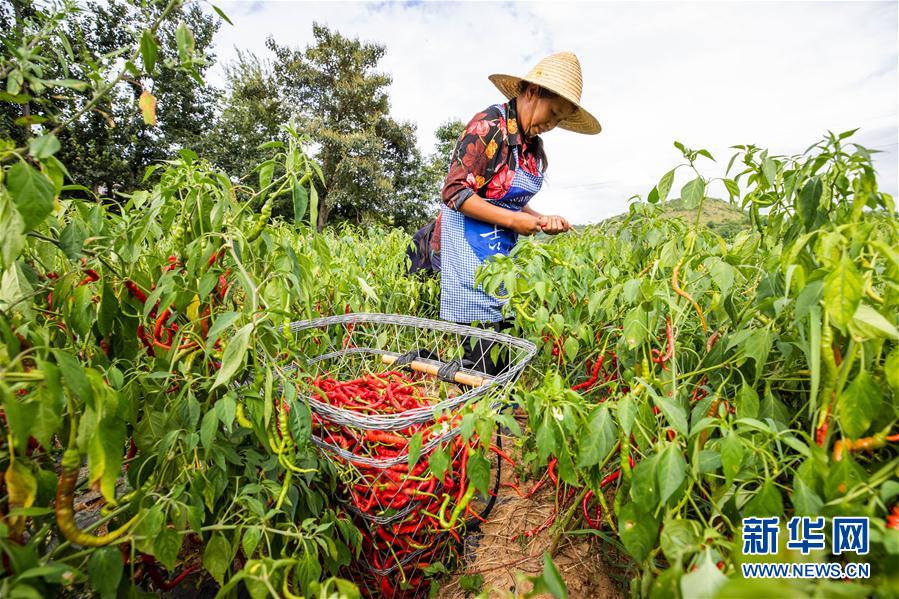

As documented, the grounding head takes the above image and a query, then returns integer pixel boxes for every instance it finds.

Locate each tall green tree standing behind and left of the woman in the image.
[266,23,428,230]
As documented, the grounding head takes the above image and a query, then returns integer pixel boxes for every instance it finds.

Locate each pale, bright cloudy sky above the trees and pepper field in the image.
[210,1,899,223]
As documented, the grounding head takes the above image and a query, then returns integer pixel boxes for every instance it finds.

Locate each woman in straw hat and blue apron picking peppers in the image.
[431,52,601,374]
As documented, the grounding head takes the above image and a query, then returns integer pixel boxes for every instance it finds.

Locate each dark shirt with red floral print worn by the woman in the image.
[431,99,545,252]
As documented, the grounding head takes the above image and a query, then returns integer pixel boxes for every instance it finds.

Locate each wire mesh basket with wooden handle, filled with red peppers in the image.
[281,313,537,597]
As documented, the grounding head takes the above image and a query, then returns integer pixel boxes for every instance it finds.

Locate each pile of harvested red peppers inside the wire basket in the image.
[309,370,492,597]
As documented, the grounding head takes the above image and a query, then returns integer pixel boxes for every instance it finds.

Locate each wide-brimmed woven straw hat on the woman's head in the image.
[490,52,602,135]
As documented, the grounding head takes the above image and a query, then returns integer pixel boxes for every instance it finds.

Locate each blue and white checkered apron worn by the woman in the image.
[440,147,543,323]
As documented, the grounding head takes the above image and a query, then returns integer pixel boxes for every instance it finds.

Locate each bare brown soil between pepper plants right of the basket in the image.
[436,437,626,599]
